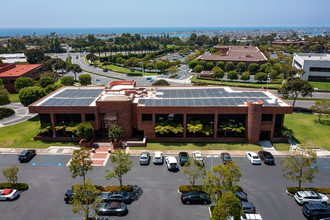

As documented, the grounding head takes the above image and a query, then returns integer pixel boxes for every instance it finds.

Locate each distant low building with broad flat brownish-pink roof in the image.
[197,46,267,71]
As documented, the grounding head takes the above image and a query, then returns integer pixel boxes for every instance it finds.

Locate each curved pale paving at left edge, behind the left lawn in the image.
[0,103,36,127]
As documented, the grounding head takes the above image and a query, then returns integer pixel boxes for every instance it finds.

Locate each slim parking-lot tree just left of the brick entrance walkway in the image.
[70,147,93,181]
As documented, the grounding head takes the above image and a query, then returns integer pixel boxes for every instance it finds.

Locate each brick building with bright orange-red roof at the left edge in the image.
[0,63,44,93]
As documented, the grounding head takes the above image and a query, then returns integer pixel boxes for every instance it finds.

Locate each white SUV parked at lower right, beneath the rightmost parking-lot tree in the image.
[294,191,329,205]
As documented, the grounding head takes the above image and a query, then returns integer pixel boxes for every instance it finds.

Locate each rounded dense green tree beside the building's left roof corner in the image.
[18,87,47,107]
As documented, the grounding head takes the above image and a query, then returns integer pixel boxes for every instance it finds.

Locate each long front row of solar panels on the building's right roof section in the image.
[139,98,278,106]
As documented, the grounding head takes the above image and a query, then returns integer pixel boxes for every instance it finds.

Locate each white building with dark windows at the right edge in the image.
[292,53,330,81]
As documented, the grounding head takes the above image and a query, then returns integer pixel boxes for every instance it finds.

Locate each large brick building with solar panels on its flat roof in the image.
[29,81,293,143]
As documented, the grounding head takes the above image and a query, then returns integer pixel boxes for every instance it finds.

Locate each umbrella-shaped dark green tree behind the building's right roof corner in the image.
[277,79,314,107]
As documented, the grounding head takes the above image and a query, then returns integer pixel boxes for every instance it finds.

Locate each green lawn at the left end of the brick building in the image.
[0,116,79,148]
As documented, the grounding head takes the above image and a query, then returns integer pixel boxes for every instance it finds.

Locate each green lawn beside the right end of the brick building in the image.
[284,113,330,150]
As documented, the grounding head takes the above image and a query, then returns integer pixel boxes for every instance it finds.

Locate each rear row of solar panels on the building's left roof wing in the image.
[54,89,103,98]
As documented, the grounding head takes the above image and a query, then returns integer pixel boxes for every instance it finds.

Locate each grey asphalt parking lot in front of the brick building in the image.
[0,154,330,220]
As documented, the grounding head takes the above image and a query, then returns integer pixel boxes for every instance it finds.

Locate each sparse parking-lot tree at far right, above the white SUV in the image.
[281,147,318,190]
